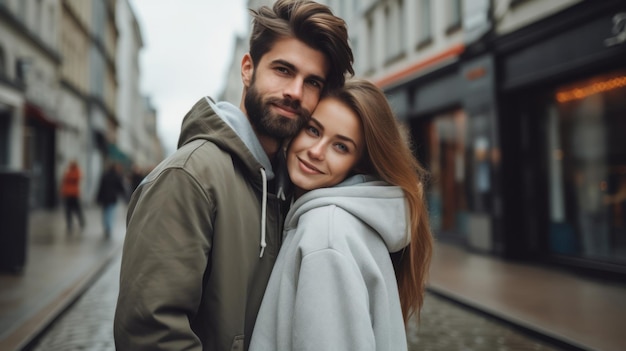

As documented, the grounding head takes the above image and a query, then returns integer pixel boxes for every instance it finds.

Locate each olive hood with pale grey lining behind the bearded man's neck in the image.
[178,96,274,179]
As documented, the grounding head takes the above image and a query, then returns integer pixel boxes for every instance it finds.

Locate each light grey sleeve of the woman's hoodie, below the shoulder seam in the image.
[292,249,376,351]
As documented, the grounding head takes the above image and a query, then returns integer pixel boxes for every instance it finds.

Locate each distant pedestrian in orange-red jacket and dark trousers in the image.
[61,160,85,234]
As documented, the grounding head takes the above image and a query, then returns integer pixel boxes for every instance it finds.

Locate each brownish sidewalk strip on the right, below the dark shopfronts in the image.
[429,243,626,351]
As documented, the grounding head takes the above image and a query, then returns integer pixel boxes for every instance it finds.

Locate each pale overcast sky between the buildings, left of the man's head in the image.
[130,0,248,155]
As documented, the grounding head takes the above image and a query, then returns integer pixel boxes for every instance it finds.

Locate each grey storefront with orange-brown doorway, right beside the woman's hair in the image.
[386,52,503,254]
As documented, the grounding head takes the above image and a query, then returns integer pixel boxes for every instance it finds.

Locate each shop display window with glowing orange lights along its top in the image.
[545,71,626,264]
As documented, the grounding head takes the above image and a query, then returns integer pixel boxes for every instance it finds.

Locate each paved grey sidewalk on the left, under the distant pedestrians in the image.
[0,203,126,351]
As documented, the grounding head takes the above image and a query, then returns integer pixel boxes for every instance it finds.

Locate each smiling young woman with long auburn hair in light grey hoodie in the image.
[250,80,432,351]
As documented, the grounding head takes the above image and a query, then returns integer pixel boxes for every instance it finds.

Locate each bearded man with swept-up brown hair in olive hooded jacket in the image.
[114,0,353,350]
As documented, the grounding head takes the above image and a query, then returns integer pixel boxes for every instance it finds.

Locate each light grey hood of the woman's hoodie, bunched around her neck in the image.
[285,175,411,252]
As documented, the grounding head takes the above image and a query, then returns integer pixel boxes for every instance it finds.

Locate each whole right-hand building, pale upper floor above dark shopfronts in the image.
[348,0,626,276]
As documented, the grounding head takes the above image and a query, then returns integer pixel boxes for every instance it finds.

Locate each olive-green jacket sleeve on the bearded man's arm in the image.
[114,168,213,350]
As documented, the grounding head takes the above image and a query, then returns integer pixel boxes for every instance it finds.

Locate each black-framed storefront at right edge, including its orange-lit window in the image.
[496,1,626,274]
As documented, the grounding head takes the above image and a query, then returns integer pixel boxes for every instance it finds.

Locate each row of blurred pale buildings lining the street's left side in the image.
[0,0,163,209]
